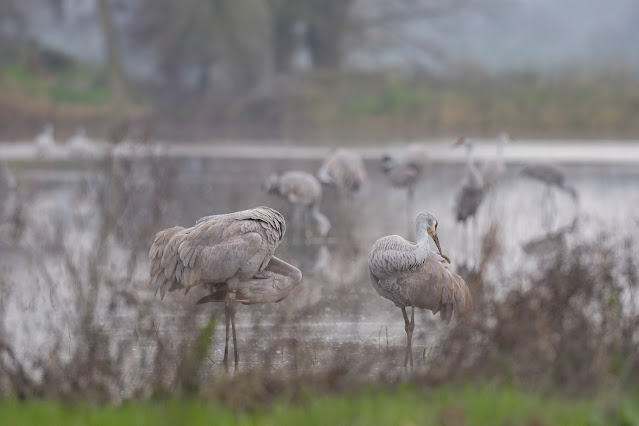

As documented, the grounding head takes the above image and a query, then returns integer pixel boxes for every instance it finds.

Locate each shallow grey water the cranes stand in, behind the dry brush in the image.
[0,141,639,392]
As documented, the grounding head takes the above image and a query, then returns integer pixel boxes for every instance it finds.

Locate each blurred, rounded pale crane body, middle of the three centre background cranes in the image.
[317,148,368,196]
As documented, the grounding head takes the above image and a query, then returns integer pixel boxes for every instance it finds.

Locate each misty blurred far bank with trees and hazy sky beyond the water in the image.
[0,0,639,140]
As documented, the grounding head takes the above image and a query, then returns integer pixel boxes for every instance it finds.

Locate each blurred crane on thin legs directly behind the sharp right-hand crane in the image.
[381,144,430,234]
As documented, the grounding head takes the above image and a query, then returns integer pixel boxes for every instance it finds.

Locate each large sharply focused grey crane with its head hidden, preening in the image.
[149,207,302,369]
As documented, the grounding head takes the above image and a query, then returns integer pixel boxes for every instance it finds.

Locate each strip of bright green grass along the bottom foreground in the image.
[0,386,639,426]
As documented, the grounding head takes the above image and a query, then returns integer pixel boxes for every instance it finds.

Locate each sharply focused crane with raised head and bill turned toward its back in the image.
[368,212,472,367]
